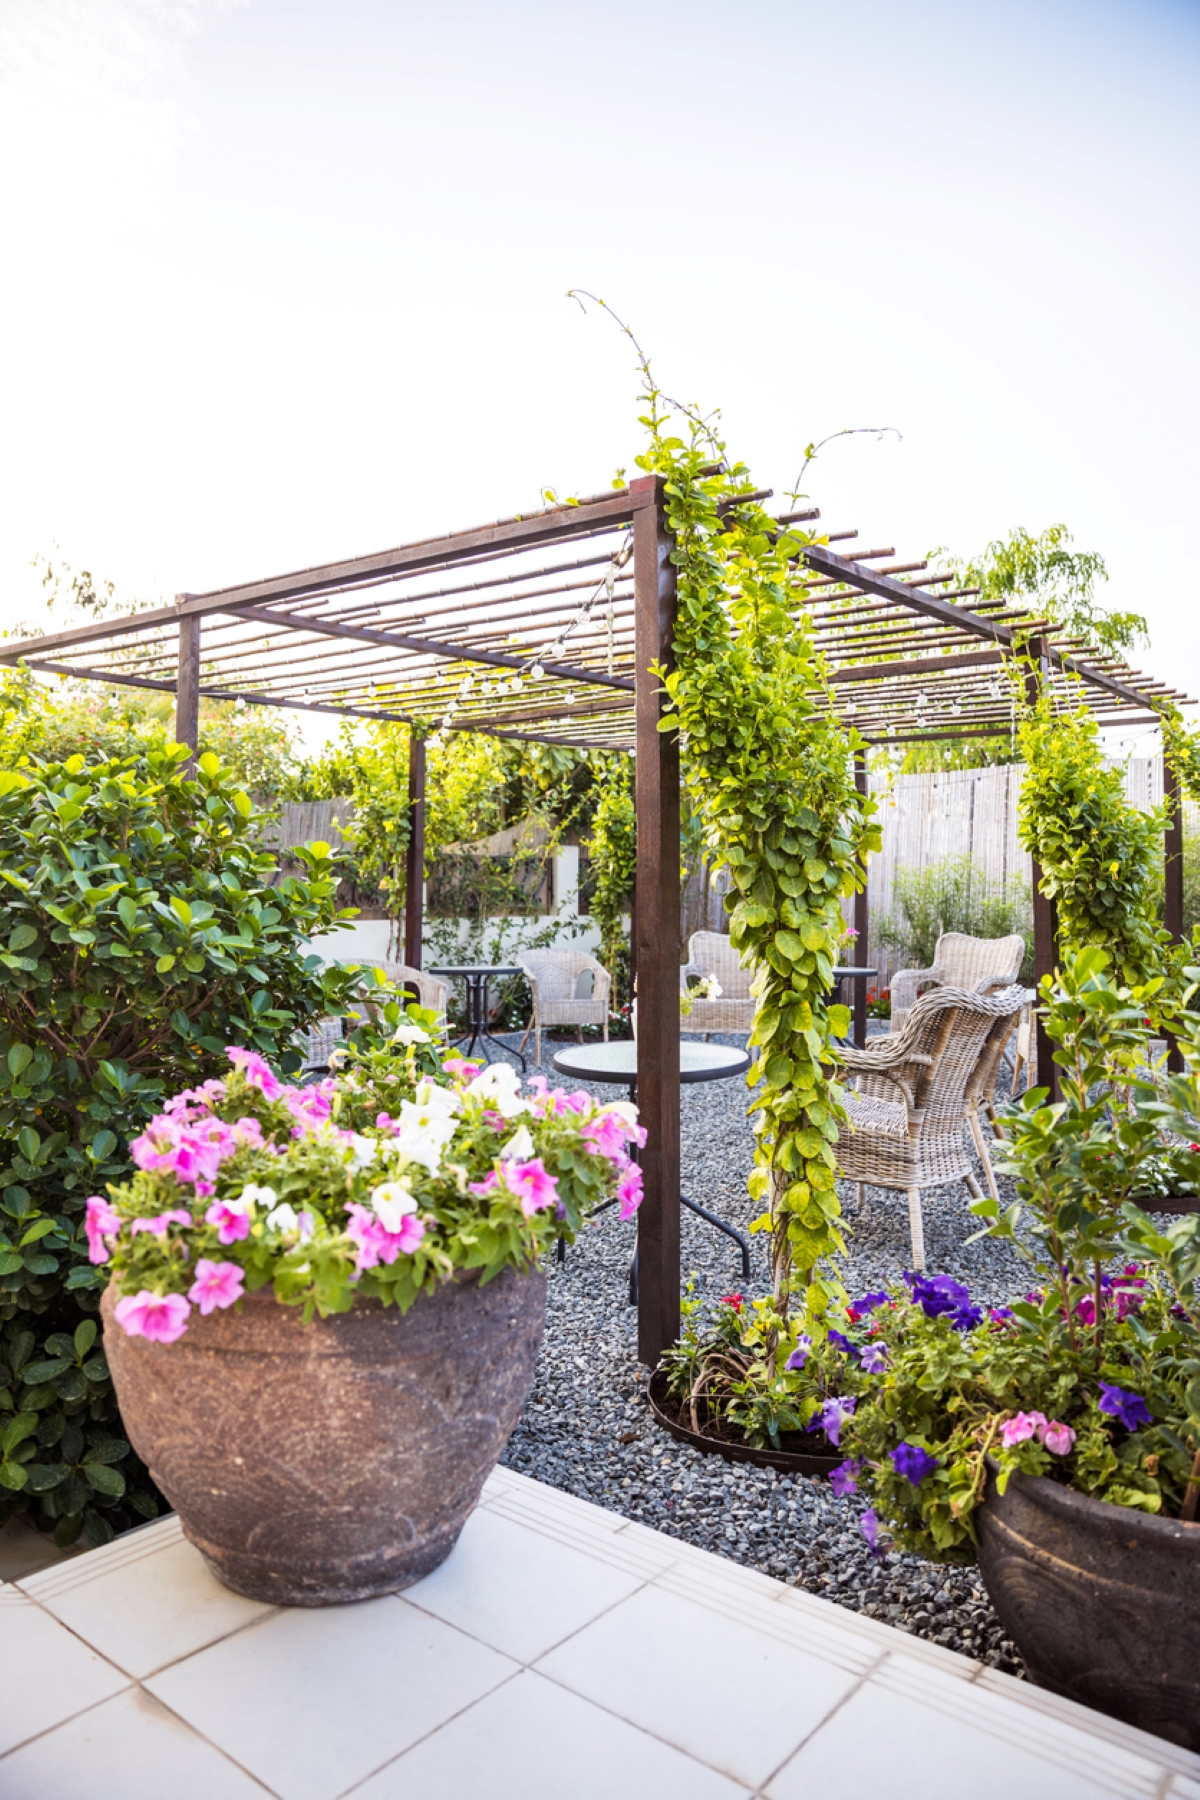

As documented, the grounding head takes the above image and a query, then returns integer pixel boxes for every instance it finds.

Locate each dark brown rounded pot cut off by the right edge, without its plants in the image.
[975,1471,1200,1750]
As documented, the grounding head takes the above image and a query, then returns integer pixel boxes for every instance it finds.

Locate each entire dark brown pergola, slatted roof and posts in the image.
[0,477,1191,1364]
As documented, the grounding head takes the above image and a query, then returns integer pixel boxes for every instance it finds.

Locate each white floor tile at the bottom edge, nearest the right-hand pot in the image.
[766,1658,1162,1800]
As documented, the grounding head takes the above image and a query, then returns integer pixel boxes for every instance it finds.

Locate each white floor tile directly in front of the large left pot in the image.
[146,1598,518,1800]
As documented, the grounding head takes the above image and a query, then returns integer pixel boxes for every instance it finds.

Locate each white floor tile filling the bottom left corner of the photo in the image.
[0,1688,266,1800]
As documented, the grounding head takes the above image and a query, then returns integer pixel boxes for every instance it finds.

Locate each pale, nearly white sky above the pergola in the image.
[0,0,1200,748]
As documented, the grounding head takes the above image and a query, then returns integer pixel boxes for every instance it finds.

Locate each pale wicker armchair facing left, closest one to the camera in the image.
[837,986,1029,1269]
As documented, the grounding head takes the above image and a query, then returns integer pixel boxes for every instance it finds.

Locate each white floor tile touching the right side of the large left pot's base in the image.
[405,1512,640,1663]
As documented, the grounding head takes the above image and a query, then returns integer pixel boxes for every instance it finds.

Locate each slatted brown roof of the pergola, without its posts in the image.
[0,475,1189,751]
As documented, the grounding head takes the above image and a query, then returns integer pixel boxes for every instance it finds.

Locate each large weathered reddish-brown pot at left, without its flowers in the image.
[101,1269,545,1606]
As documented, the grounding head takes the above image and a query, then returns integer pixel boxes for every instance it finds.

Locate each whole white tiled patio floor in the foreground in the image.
[0,1471,1200,1800]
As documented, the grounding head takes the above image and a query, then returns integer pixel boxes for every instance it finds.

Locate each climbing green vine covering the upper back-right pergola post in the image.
[1018,697,1169,985]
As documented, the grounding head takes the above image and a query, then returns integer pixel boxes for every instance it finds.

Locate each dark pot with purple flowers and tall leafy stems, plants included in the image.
[820,949,1200,1750]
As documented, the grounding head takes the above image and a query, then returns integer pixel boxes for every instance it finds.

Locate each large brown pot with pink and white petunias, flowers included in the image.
[86,1003,644,1606]
